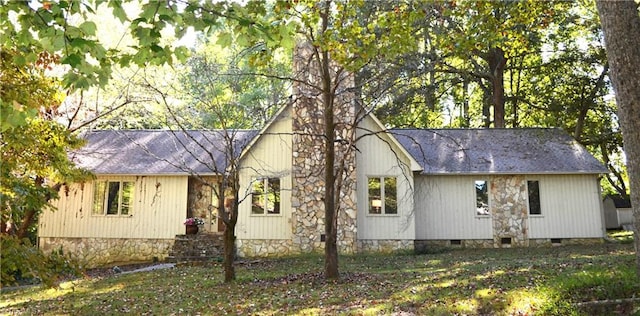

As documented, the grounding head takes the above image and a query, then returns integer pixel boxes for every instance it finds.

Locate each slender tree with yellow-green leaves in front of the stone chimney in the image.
[232,0,421,279]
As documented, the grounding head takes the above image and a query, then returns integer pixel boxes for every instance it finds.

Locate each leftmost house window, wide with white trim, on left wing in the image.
[92,181,135,215]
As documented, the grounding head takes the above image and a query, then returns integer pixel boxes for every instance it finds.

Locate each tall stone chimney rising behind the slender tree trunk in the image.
[291,43,357,253]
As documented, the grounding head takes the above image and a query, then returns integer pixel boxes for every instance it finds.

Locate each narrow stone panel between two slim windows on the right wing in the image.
[491,176,529,247]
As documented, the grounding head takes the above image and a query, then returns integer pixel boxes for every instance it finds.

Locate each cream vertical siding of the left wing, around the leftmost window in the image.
[38,176,187,238]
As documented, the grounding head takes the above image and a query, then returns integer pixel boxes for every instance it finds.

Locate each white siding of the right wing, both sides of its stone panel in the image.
[415,175,604,240]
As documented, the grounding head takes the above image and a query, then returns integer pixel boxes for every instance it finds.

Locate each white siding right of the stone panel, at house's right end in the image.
[527,175,605,238]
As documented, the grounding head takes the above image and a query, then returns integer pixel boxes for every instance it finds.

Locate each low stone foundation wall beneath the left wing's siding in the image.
[39,237,174,268]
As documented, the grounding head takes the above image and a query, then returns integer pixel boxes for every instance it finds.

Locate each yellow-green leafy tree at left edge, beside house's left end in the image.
[0,51,89,238]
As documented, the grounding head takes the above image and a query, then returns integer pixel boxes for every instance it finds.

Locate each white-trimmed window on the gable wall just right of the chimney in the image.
[367,177,398,215]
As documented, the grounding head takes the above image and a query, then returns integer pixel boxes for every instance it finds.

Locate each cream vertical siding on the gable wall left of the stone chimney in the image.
[236,109,293,239]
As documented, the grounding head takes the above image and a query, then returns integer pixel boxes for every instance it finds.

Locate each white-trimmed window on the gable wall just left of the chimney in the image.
[251,178,280,215]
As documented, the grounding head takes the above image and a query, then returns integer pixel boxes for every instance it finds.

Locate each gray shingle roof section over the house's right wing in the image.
[391,128,608,174]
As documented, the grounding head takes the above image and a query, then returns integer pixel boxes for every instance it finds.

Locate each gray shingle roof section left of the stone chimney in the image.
[71,130,256,175]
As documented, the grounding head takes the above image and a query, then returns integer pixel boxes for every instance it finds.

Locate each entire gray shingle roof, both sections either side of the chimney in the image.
[77,128,608,175]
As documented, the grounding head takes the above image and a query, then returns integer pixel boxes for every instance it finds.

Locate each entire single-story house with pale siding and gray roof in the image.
[38,101,607,264]
